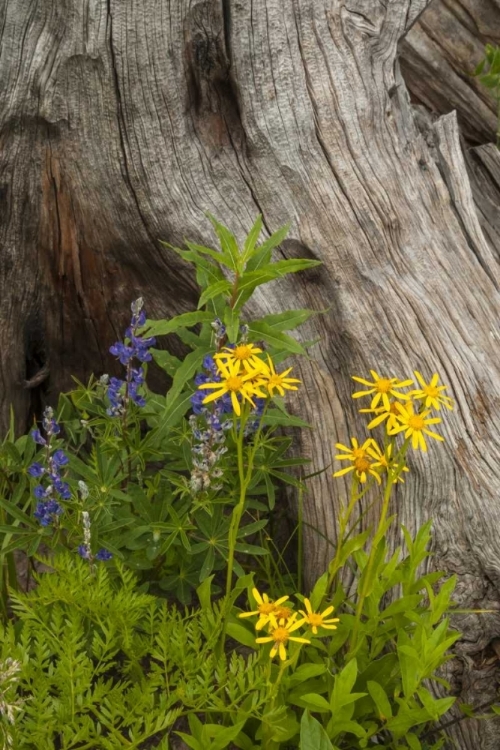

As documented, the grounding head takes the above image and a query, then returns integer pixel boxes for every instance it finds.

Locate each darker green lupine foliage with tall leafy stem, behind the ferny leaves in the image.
[0,212,317,613]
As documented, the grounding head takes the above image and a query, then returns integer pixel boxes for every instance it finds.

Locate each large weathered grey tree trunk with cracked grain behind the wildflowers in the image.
[0,0,500,750]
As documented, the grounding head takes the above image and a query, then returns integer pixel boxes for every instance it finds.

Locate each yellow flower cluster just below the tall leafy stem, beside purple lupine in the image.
[198,344,300,416]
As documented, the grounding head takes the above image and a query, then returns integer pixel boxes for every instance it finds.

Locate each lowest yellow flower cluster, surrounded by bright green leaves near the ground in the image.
[239,588,339,661]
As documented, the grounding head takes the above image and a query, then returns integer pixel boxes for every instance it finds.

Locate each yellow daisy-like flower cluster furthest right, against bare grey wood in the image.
[333,370,453,484]
